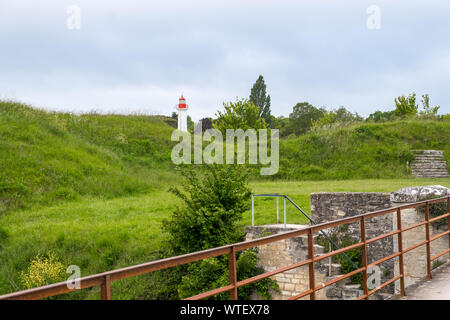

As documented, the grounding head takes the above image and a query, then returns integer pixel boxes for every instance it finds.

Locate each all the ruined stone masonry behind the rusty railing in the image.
[246,185,450,300]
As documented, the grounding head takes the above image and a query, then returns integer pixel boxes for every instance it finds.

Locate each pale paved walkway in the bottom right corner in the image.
[401,262,450,300]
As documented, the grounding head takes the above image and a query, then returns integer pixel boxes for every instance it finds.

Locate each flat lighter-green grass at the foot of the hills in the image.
[0,179,450,299]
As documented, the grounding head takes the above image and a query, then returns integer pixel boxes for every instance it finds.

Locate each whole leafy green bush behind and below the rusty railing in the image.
[163,165,276,299]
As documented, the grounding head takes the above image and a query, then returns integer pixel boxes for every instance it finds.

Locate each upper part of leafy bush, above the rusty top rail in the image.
[163,165,251,254]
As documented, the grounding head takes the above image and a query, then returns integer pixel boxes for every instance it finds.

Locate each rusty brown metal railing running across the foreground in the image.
[0,197,450,300]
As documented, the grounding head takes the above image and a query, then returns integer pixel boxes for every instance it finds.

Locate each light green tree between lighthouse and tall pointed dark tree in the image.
[213,99,267,134]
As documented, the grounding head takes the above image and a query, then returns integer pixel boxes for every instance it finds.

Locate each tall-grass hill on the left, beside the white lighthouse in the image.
[0,101,178,215]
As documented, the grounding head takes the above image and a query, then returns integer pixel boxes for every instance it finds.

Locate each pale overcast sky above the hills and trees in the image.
[0,0,450,120]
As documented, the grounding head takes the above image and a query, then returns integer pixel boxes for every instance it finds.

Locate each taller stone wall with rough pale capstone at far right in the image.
[311,186,450,293]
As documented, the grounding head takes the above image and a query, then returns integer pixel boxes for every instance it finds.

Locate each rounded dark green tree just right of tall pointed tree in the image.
[289,102,326,135]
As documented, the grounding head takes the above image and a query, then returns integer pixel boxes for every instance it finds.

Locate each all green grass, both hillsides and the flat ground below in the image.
[0,101,450,298]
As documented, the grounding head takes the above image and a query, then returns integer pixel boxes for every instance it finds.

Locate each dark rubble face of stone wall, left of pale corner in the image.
[311,192,394,293]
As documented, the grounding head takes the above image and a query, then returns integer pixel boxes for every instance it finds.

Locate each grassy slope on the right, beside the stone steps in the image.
[279,120,450,180]
